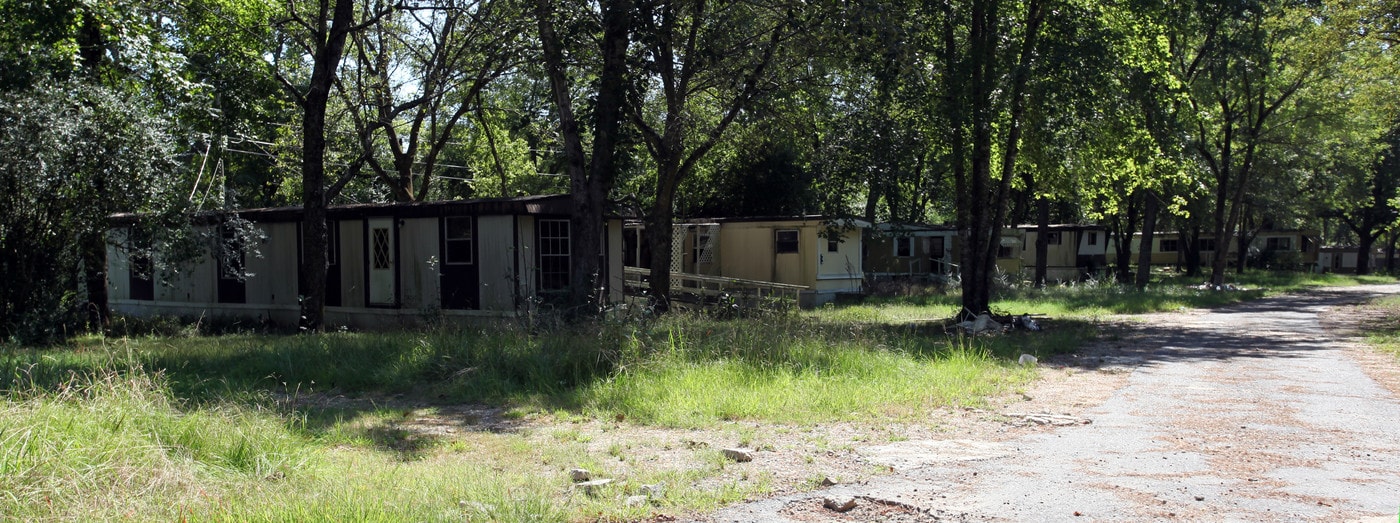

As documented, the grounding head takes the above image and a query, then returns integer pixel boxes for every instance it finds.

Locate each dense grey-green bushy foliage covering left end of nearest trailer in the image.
[0,83,188,341]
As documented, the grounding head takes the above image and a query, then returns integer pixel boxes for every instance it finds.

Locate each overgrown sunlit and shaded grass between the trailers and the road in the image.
[0,275,1400,522]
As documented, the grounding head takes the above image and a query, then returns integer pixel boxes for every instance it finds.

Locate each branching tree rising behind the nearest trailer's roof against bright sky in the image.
[337,0,525,201]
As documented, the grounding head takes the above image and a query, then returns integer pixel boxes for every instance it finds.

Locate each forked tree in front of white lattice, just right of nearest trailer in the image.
[629,0,799,310]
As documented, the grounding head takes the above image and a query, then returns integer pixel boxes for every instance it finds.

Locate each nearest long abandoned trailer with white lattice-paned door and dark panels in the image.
[108,194,623,329]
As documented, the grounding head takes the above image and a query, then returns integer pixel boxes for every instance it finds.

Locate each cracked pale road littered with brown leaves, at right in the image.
[706,285,1400,522]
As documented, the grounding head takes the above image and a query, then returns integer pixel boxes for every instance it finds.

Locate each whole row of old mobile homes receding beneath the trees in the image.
[108,196,1376,329]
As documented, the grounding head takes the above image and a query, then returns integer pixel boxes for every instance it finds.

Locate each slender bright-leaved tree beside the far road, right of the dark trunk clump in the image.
[1151,0,1355,285]
